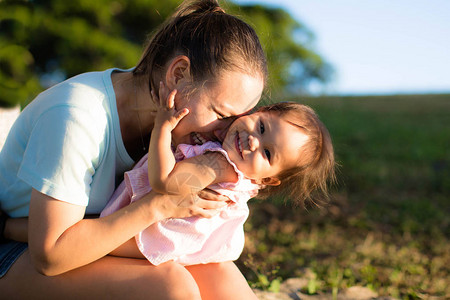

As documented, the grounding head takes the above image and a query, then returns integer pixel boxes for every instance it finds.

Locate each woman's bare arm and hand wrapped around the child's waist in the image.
[28,190,224,276]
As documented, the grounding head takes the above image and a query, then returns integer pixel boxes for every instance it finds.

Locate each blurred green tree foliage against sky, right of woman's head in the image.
[230,5,333,94]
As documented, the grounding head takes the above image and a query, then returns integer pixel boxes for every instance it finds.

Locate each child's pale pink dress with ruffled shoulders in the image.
[101,142,259,265]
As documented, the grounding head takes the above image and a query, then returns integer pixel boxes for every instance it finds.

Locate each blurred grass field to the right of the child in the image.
[238,95,450,299]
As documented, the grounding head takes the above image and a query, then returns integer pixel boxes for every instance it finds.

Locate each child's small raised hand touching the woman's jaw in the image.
[151,81,189,131]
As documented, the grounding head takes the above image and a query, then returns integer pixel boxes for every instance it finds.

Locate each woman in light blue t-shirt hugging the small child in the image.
[0,0,267,299]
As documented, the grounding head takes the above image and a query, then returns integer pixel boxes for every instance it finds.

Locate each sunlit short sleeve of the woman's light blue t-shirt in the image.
[18,106,104,206]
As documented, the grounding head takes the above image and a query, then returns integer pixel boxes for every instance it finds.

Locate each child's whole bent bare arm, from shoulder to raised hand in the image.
[148,84,237,196]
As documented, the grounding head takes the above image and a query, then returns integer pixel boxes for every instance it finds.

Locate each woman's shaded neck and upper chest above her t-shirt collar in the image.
[112,72,155,161]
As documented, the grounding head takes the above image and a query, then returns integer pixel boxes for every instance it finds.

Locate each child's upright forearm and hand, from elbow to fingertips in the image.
[148,82,189,194]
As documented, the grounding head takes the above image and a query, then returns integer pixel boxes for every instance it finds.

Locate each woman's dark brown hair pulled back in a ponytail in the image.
[133,0,267,91]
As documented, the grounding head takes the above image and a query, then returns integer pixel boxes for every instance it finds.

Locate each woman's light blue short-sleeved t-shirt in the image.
[0,69,134,217]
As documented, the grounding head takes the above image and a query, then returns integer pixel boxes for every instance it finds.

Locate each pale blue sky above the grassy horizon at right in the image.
[235,0,450,94]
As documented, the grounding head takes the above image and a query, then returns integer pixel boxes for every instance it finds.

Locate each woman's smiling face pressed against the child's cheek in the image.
[172,71,264,145]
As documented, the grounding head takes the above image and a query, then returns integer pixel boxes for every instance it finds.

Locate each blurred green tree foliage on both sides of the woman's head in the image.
[0,0,328,106]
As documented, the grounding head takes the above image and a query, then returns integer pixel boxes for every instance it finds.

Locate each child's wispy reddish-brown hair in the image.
[257,102,335,206]
